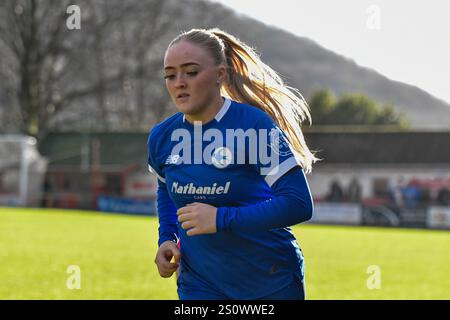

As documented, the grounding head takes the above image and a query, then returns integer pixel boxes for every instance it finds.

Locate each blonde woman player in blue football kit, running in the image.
[148,28,319,300]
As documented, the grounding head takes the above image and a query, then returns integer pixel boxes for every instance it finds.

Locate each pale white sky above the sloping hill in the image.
[211,0,450,103]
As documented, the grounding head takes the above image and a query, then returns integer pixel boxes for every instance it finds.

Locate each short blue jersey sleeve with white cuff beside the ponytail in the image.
[256,115,301,186]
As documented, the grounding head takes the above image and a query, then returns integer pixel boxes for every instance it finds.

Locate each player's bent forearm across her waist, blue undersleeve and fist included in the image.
[177,166,314,236]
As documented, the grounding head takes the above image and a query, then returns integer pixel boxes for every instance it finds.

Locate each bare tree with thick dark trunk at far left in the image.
[0,0,92,135]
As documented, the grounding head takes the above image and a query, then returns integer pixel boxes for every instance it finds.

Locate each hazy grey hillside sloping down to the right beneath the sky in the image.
[186,2,450,129]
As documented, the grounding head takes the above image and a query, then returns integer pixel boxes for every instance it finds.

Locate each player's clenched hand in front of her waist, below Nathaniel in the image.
[177,202,217,236]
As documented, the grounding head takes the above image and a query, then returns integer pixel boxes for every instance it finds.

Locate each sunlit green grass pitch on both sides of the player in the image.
[0,208,450,299]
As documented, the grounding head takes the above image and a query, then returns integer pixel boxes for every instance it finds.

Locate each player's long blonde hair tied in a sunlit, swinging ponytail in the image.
[169,28,321,173]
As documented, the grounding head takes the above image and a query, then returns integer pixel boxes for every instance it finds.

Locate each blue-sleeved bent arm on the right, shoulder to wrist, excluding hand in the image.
[212,115,314,232]
